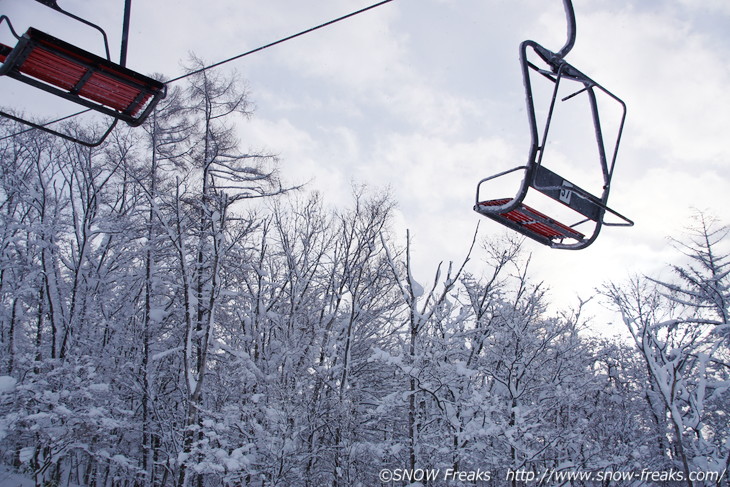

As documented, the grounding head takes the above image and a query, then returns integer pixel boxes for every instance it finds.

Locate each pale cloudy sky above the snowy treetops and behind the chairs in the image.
[0,0,730,332]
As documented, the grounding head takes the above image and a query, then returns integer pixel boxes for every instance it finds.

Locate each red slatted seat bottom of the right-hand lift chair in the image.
[474,198,585,245]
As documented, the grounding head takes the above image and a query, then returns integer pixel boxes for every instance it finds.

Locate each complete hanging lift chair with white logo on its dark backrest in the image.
[474,0,633,250]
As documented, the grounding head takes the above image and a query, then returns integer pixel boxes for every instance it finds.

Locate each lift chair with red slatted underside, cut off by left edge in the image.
[0,0,166,147]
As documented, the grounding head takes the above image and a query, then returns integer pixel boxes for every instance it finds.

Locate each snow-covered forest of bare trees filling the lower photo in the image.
[0,66,730,487]
